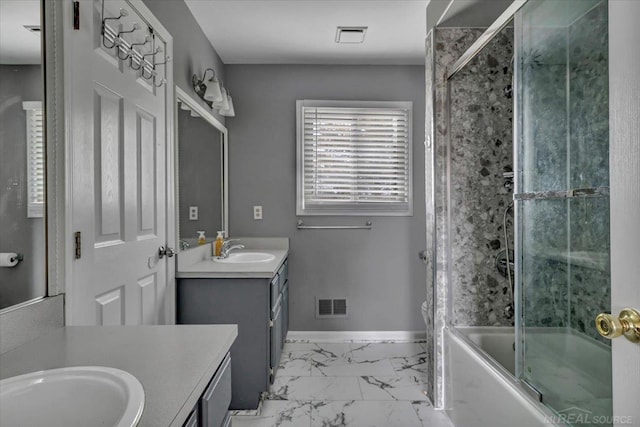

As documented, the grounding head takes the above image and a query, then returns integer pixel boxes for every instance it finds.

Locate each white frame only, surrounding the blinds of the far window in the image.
[296,99,413,216]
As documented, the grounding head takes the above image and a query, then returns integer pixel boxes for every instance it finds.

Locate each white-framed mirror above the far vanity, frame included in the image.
[175,87,229,251]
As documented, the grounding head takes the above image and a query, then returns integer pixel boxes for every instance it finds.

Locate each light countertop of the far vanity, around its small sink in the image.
[176,238,289,279]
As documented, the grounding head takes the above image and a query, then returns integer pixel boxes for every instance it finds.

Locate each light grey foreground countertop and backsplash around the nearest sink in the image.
[0,325,238,427]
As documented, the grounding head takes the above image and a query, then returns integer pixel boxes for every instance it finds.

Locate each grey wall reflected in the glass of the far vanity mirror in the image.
[178,110,222,241]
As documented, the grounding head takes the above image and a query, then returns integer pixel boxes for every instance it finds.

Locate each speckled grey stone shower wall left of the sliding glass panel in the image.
[448,28,513,326]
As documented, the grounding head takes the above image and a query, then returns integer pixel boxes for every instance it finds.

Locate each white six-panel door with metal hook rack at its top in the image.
[65,0,174,325]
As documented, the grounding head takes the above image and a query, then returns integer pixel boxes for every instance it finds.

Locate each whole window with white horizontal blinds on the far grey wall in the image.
[296,100,413,216]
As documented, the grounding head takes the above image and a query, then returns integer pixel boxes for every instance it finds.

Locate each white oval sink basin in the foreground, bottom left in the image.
[0,366,144,427]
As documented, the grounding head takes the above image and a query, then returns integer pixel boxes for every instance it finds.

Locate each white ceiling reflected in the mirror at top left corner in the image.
[0,0,41,64]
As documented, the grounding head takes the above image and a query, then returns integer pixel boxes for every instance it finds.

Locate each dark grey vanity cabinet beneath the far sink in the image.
[177,259,289,409]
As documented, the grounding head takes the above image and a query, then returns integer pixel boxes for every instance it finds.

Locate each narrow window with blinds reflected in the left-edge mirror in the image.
[22,101,45,218]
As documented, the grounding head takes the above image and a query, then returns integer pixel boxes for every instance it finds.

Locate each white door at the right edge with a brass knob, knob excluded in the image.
[609,0,640,426]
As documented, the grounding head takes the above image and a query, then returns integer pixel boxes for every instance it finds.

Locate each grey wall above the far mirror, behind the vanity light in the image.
[143,0,226,124]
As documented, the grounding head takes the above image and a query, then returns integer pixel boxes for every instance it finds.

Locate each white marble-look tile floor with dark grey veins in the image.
[231,342,453,427]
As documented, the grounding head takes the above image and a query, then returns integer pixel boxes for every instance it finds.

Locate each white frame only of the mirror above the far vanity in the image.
[174,86,229,252]
